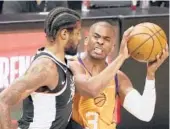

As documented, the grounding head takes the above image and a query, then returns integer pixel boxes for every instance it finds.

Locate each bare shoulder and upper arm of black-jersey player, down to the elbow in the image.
[0,58,58,105]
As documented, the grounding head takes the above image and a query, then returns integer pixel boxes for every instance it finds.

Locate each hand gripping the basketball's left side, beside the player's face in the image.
[119,26,134,59]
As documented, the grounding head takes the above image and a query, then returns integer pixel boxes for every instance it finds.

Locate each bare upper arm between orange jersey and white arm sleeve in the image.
[118,71,133,103]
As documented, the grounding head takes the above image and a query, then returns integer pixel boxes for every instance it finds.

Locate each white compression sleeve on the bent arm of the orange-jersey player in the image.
[123,80,156,122]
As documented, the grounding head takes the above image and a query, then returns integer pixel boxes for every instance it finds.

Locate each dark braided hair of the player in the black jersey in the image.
[44,7,80,40]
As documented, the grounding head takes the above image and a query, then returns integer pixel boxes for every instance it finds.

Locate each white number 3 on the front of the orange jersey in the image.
[85,112,99,129]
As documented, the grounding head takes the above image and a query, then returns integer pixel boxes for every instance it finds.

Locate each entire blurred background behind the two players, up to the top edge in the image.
[0,0,169,129]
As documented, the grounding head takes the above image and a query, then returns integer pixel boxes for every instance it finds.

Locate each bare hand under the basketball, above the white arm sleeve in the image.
[147,45,169,77]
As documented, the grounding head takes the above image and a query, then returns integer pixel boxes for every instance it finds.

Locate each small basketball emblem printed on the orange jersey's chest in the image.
[94,93,106,107]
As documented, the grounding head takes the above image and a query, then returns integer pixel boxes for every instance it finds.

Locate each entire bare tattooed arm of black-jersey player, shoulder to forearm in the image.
[0,59,56,129]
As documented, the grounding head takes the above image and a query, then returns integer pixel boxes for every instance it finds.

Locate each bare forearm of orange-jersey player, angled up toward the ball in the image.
[88,56,124,95]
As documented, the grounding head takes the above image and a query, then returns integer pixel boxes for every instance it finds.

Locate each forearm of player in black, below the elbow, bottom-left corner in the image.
[0,104,11,129]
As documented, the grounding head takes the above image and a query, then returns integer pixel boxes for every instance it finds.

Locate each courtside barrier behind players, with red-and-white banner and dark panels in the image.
[0,8,169,129]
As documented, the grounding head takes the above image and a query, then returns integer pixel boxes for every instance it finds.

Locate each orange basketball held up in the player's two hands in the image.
[128,22,167,62]
